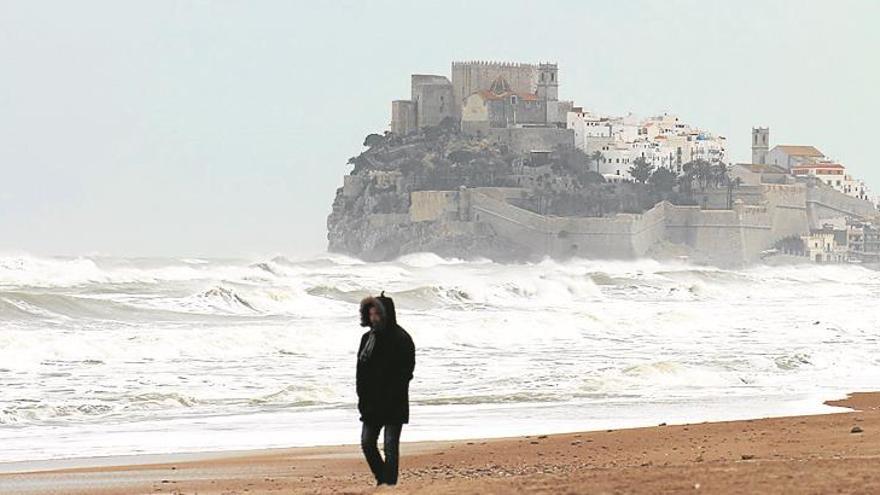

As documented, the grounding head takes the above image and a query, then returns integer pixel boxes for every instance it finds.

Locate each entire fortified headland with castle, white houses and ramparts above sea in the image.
[327,62,880,265]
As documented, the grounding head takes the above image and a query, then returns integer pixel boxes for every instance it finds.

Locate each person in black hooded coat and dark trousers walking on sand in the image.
[357,291,416,485]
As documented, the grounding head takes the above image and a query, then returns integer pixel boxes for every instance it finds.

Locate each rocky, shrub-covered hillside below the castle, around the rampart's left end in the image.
[327,122,657,260]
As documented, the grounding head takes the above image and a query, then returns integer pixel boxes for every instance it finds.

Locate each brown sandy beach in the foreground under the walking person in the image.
[0,392,880,494]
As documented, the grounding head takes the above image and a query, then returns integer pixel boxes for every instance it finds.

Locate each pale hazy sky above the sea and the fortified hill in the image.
[0,0,880,257]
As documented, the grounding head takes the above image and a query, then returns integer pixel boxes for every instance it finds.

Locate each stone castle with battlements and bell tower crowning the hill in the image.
[391,62,574,151]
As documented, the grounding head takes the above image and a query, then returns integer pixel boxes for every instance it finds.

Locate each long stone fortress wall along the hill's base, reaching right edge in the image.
[343,170,877,265]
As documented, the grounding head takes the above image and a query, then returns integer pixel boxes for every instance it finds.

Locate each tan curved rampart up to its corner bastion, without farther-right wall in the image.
[410,184,868,264]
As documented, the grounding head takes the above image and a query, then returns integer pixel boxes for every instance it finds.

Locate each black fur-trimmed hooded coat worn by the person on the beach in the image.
[357,293,416,425]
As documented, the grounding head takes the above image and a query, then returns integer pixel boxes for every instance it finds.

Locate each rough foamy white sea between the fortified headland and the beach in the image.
[0,254,880,462]
